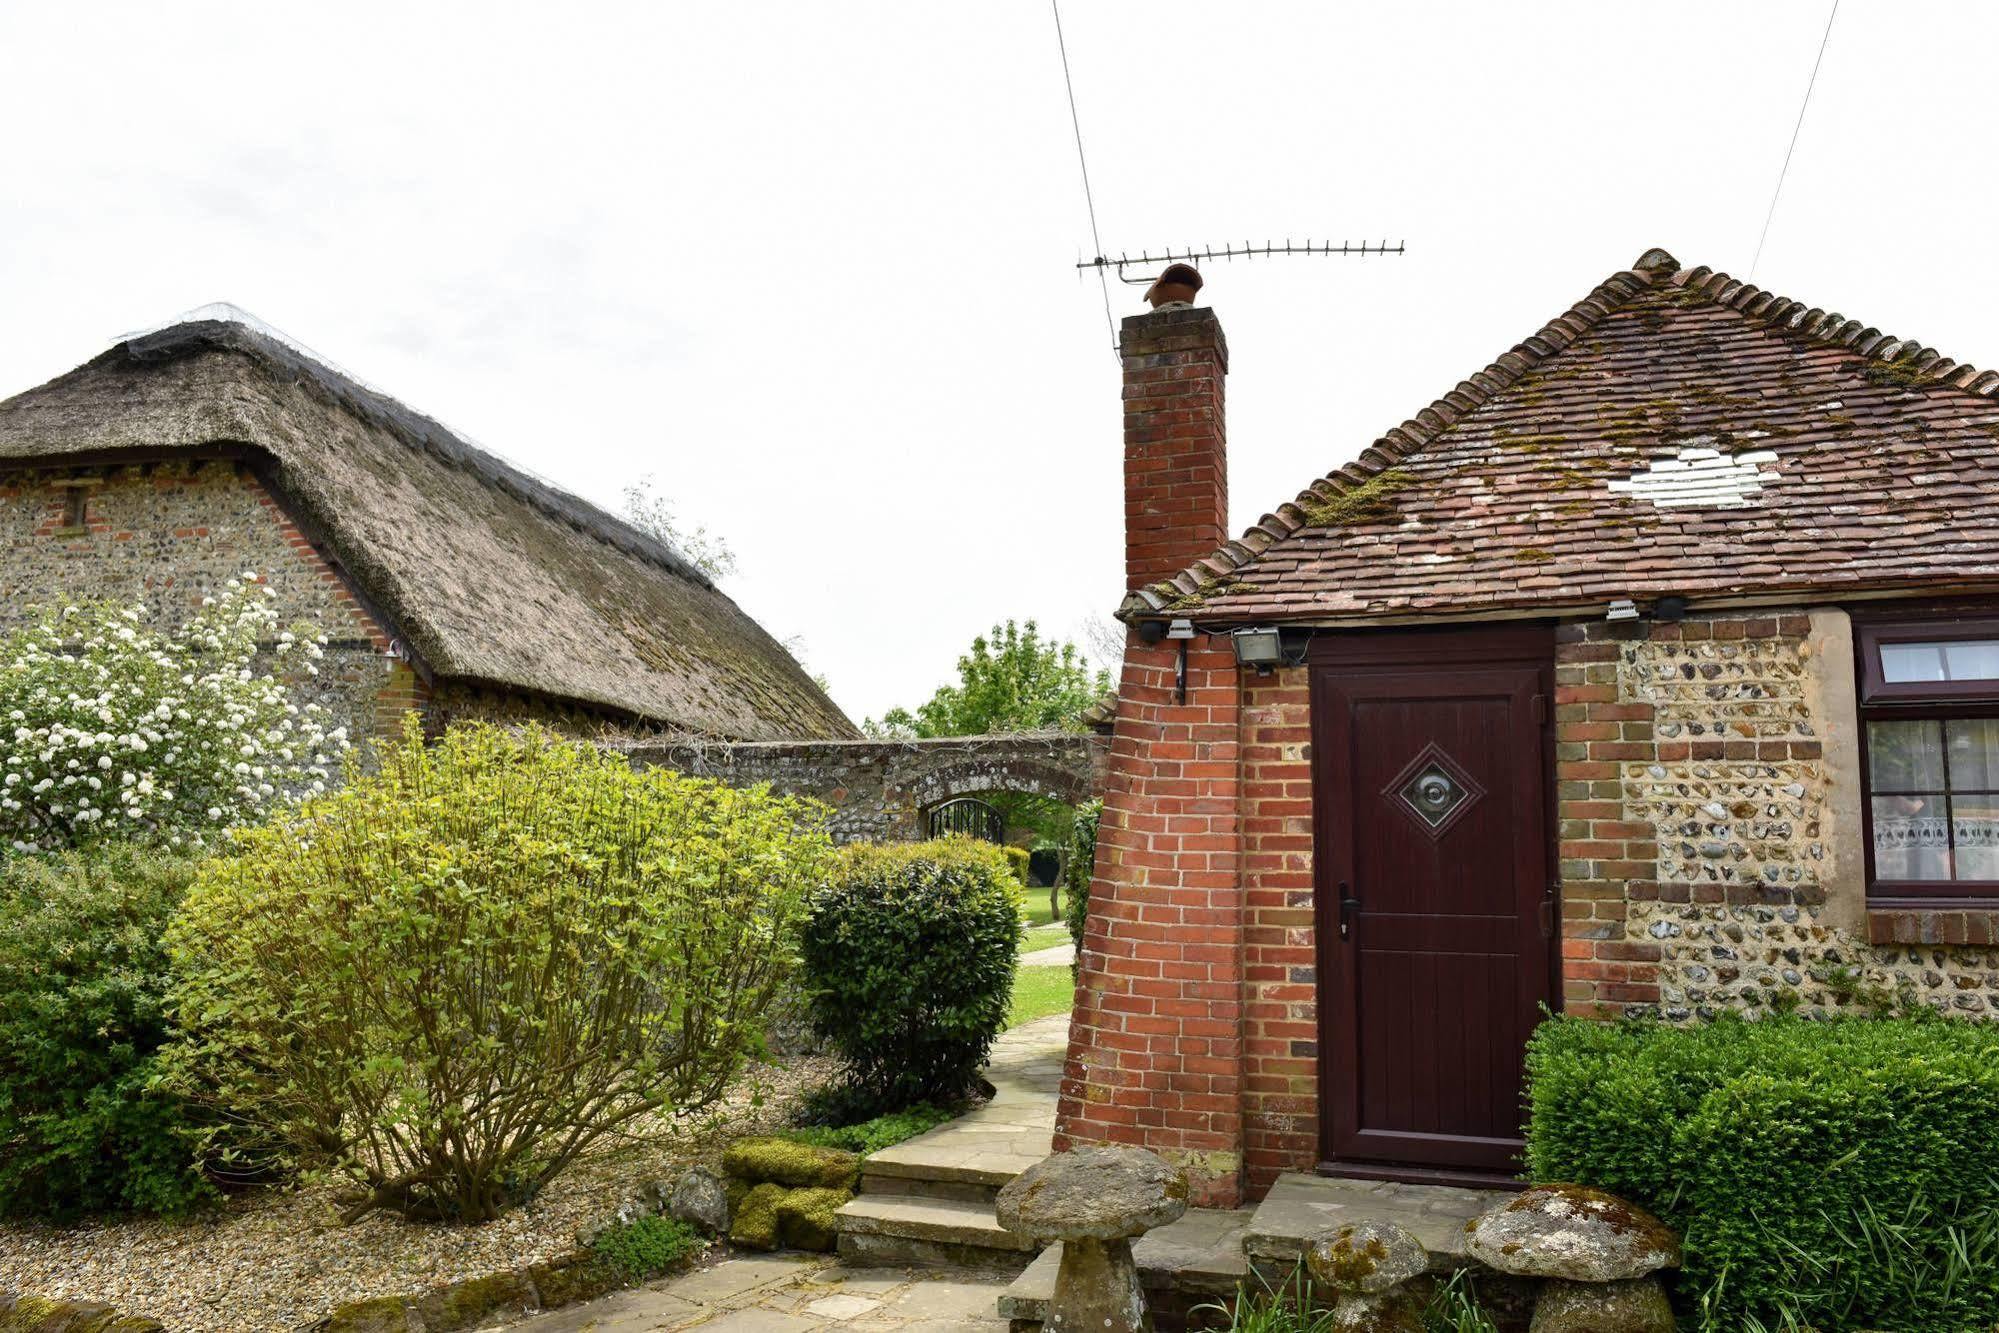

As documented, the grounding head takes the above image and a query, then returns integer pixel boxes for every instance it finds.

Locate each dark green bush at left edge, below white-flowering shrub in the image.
[0,847,214,1219]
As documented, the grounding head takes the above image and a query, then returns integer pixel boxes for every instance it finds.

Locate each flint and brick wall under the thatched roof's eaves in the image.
[0,460,411,739]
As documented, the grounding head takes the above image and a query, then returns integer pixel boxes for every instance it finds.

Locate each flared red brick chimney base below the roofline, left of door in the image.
[1055,636,1245,1207]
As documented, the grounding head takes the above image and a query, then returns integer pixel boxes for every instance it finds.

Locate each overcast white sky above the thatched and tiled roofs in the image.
[0,0,1999,719]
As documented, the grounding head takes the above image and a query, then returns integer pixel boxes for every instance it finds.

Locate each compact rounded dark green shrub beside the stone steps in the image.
[802,837,1023,1119]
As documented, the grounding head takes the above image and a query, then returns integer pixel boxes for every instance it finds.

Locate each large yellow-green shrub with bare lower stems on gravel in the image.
[168,721,830,1221]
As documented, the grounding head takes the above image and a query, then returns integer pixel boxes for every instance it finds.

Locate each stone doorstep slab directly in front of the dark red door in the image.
[1243,1175,1513,1273]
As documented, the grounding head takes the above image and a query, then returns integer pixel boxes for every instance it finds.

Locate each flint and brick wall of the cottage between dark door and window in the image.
[1555,610,1999,1019]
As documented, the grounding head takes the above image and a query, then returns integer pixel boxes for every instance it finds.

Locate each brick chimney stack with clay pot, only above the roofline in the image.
[1119,297,1229,592]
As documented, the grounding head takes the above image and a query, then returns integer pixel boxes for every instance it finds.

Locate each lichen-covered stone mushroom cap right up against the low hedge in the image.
[1465,1185,1679,1283]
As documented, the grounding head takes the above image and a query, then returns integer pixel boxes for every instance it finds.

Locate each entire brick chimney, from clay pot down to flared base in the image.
[1055,264,1245,1207]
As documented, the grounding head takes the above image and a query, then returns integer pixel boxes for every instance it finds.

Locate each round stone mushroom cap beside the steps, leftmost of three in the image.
[994,1147,1187,1241]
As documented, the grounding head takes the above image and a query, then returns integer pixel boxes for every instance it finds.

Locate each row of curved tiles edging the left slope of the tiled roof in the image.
[1117,250,1679,620]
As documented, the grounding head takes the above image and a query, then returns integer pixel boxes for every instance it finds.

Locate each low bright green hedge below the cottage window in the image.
[1527,1017,1999,1333]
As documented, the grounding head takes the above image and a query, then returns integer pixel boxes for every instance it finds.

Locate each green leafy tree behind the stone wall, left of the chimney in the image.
[866,620,1111,737]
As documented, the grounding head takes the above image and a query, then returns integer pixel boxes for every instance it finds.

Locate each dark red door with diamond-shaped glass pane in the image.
[1311,630,1555,1173]
